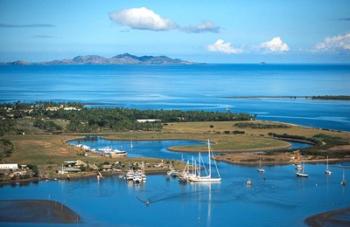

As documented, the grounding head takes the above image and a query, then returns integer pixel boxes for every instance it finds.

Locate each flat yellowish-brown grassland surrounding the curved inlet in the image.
[2,121,350,173]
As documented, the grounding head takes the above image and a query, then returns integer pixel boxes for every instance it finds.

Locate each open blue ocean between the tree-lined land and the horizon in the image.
[0,64,350,131]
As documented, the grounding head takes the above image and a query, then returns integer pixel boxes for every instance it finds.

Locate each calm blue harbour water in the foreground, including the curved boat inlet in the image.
[0,139,350,226]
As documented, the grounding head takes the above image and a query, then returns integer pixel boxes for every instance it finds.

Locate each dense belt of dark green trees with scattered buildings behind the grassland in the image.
[0,102,255,136]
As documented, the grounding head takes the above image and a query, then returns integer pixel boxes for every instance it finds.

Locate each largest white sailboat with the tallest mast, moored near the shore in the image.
[188,139,221,183]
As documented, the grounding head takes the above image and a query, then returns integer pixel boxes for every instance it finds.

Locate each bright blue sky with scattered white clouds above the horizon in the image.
[0,0,350,63]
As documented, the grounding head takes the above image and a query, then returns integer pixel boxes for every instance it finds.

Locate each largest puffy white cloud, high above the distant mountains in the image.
[109,7,176,31]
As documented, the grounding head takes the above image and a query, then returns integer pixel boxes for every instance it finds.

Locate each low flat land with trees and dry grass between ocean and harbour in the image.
[0,102,350,183]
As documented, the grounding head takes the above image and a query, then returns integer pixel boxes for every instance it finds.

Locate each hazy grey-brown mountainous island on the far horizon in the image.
[6,53,194,65]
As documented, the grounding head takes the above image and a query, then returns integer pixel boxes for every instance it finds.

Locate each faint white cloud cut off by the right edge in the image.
[315,33,350,51]
